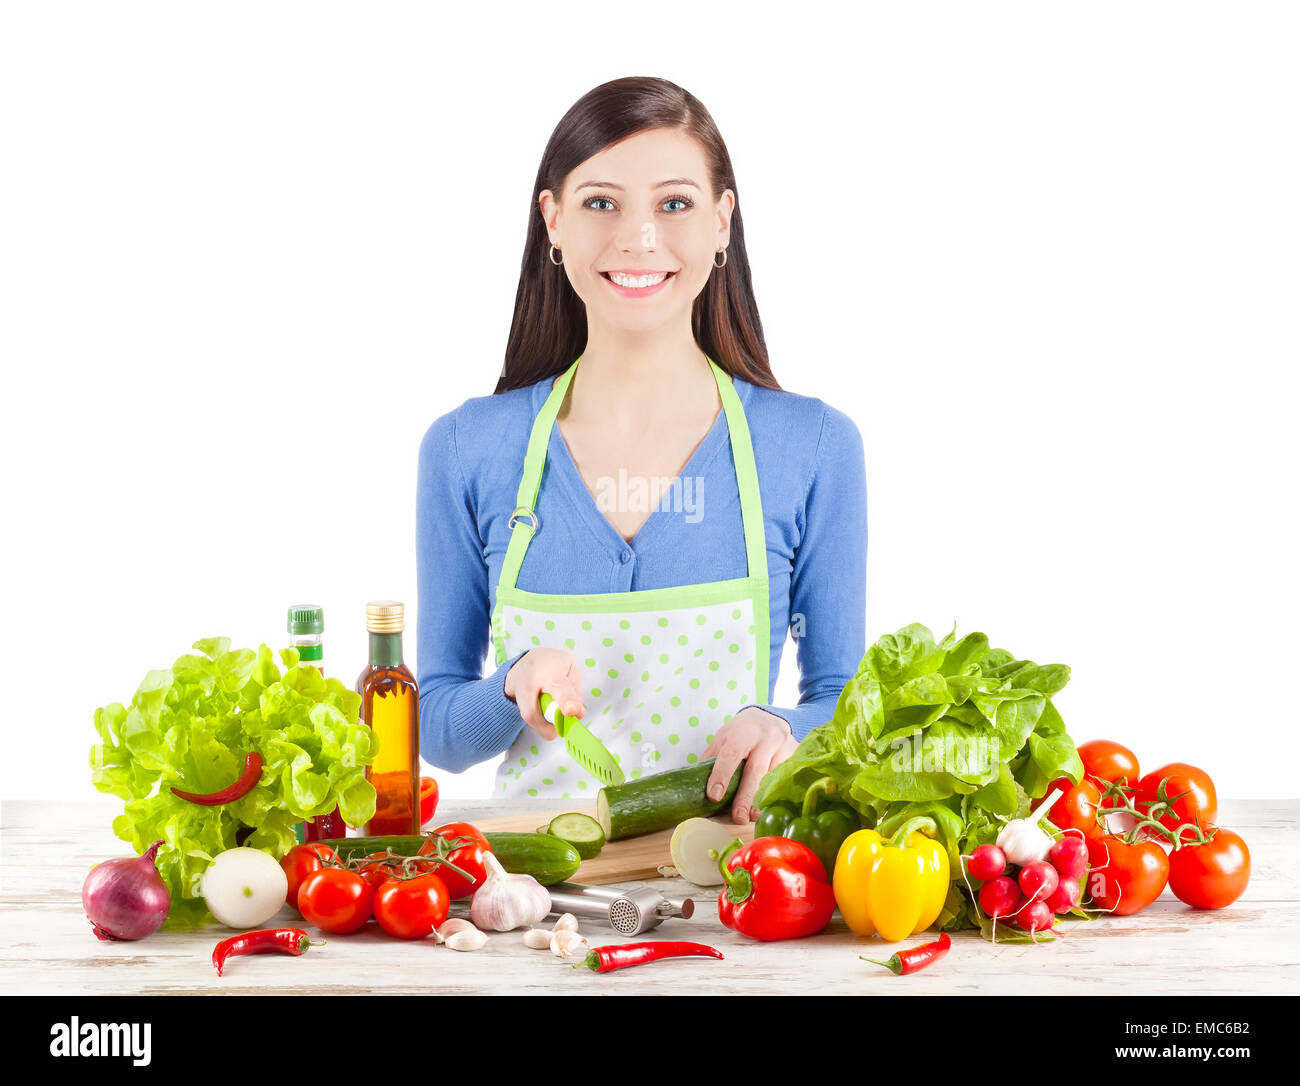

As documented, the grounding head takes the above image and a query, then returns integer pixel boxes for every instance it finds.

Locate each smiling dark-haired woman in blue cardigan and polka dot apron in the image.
[417,78,866,823]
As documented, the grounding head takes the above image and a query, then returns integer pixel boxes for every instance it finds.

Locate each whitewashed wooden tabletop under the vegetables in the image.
[0,799,1300,995]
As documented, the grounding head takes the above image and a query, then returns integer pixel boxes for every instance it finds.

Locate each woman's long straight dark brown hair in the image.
[497,75,780,393]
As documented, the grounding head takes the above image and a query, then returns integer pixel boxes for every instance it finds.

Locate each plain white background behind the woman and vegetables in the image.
[0,0,1300,797]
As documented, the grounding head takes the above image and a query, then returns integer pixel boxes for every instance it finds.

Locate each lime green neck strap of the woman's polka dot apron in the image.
[498,355,767,595]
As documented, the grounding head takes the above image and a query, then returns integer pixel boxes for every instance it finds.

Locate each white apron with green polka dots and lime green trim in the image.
[491,358,768,800]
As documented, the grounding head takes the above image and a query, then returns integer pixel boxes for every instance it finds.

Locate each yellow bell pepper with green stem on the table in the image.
[832,815,948,943]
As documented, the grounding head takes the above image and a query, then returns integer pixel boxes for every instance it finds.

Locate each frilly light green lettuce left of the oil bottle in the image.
[90,637,377,927]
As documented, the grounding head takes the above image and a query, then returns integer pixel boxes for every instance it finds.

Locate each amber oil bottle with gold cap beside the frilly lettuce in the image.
[356,601,420,836]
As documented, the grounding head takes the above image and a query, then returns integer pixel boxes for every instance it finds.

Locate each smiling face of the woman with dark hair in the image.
[538,129,736,332]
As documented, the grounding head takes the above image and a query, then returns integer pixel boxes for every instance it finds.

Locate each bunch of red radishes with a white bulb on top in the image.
[962,792,1088,935]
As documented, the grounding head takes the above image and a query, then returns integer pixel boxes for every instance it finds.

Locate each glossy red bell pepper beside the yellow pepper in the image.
[718,838,835,942]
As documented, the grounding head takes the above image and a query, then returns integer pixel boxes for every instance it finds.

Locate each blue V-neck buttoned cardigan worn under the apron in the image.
[416,377,867,773]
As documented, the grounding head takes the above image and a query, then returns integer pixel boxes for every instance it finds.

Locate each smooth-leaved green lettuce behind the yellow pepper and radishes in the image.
[755,624,1083,927]
